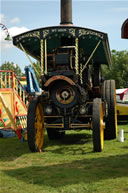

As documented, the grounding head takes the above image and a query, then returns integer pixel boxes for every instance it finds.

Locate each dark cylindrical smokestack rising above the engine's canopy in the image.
[60,0,73,25]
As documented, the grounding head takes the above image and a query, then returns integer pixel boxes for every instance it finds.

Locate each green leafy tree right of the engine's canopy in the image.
[102,50,128,88]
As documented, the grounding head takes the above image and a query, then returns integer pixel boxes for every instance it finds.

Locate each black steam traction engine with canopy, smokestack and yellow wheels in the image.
[13,0,117,152]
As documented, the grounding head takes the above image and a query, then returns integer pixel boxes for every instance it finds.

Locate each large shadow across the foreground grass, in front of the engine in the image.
[3,154,128,188]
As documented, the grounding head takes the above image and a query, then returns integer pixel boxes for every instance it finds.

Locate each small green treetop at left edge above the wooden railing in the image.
[0,62,22,76]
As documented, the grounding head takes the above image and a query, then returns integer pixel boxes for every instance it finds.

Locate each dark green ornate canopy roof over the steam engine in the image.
[13,26,111,65]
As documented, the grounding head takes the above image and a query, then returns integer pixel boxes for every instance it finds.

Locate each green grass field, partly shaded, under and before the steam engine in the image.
[0,122,128,193]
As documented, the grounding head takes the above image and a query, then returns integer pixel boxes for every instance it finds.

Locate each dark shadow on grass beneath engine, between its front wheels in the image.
[44,133,92,155]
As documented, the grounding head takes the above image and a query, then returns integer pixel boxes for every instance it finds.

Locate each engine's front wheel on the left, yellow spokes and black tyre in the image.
[27,99,44,152]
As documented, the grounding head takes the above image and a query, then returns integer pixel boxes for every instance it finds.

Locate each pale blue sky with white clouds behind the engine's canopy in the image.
[0,0,128,72]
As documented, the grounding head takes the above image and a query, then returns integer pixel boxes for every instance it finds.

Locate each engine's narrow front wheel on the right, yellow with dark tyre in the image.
[92,98,104,152]
